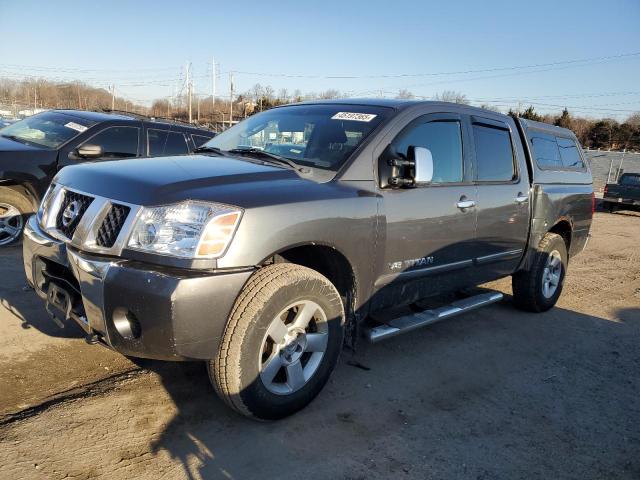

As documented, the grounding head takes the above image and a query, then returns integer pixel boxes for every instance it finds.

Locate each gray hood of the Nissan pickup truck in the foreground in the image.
[54,155,314,206]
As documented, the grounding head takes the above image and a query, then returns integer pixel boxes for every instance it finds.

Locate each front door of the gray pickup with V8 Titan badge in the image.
[373,114,477,309]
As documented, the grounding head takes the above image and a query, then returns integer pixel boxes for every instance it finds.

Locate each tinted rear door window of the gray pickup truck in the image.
[473,125,516,182]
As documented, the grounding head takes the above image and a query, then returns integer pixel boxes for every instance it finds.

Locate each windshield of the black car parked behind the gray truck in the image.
[0,112,95,149]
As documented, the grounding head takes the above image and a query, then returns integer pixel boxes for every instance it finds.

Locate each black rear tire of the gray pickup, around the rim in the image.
[511,233,568,312]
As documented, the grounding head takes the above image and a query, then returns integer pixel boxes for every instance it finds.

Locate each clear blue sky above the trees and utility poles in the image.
[0,0,640,118]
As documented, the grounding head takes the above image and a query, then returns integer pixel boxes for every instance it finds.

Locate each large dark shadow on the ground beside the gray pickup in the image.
[129,300,640,479]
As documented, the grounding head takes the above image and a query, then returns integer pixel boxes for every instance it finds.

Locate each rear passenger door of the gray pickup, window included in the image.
[470,116,530,282]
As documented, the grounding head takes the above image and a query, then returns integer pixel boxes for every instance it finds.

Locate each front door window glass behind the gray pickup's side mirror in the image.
[392,120,463,183]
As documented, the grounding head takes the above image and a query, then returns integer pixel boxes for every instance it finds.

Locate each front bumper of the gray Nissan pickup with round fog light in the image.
[23,216,253,360]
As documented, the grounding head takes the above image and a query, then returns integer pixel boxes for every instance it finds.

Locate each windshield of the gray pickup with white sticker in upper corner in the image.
[208,105,391,171]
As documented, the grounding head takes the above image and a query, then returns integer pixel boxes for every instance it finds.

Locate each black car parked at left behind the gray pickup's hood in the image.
[0,110,214,246]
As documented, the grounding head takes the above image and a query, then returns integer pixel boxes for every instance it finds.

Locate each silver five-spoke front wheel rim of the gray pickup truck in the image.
[258,300,329,395]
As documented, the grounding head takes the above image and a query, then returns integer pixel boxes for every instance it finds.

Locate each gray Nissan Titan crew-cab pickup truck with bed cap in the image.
[23,100,594,419]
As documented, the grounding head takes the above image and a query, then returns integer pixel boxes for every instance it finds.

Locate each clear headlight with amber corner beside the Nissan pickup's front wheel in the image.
[129,201,242,258]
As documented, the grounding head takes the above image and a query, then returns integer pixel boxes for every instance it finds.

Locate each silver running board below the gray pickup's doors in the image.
[364,292,503,343]
